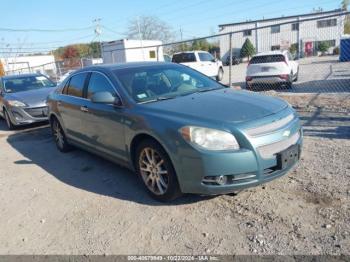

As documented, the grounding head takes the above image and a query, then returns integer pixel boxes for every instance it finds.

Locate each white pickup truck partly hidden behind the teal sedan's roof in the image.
[172,51,224,81]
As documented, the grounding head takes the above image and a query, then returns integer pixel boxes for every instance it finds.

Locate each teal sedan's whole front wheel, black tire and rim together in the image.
[134,139,182,202]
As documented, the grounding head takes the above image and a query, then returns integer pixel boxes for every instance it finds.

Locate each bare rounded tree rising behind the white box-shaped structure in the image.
[125,16,174,43]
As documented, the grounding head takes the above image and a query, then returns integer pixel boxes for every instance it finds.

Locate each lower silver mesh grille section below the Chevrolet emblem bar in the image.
[258,131,300,159]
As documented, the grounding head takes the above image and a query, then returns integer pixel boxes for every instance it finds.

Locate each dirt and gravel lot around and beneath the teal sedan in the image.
[0,93,350,255]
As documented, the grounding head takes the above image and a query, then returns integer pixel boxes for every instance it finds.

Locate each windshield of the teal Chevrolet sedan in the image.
[114,65,226,103]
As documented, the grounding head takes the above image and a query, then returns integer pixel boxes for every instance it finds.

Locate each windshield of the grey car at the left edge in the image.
[4,76,56,93]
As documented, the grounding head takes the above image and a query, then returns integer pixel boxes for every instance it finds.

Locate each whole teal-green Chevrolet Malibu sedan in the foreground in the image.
[48,62,303,201]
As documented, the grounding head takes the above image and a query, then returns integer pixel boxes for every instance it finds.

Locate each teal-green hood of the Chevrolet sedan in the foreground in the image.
[145,88,288,123]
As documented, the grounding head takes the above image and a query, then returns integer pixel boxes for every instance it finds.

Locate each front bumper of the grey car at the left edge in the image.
[7,106,48,126]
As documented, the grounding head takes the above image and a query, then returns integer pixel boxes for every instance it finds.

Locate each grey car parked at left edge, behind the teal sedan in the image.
[0,74,56,130]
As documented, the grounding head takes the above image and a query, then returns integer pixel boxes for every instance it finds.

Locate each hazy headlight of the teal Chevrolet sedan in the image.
[180,126,239,151]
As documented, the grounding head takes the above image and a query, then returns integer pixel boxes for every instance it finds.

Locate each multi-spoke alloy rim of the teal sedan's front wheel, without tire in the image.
[139,147,169,195]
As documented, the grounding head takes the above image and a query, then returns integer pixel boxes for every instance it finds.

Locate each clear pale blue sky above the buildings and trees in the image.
[0,0,341,53]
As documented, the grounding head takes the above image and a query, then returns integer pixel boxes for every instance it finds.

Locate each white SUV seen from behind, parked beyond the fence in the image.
[246,51,299,88]
